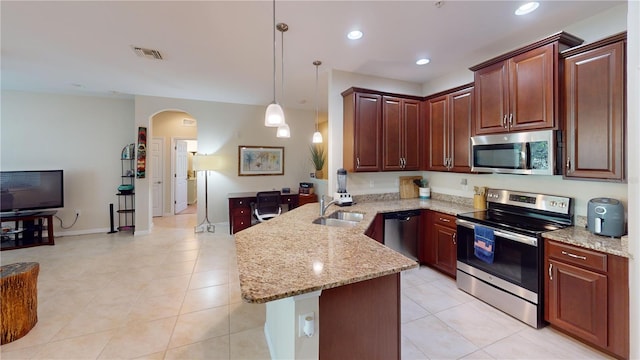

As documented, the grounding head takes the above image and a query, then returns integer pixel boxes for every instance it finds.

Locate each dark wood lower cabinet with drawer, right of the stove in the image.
[544,239,629,359]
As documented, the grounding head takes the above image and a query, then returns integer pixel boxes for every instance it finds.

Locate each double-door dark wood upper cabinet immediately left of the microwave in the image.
[426,84,474,172]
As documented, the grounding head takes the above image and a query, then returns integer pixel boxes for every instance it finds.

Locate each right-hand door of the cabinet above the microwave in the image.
[507,43,558,131]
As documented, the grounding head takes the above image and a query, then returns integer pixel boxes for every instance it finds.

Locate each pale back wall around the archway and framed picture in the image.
[135,96,315,232]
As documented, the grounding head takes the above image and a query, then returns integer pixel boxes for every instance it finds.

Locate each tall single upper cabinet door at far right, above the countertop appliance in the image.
[563,42,625,180]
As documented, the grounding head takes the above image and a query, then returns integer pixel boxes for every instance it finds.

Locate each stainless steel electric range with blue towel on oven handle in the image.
[456,189,573,328]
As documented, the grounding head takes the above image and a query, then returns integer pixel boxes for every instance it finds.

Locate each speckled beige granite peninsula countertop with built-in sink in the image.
[235,199,473,303]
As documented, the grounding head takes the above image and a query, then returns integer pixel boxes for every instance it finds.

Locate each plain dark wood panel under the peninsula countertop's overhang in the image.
[319,273,401,360]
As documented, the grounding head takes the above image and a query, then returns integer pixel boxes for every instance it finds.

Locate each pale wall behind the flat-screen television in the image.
[0,91,136,235]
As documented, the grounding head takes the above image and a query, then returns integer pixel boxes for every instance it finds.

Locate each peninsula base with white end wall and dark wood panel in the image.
[265,273,401,360]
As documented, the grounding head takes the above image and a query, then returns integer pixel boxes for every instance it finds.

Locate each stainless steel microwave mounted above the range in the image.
[471,130,560,175]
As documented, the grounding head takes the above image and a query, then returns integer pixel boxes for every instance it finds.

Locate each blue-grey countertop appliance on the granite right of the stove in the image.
[587,198,625,237]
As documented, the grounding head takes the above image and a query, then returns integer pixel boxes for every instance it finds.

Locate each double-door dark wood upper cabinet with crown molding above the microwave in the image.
[470,32,582,135]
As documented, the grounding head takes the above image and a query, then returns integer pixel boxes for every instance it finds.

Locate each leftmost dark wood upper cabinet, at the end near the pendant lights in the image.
[342,89,382,172]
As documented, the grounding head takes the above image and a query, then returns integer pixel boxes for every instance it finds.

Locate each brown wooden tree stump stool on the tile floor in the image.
[0,262,40,344]
